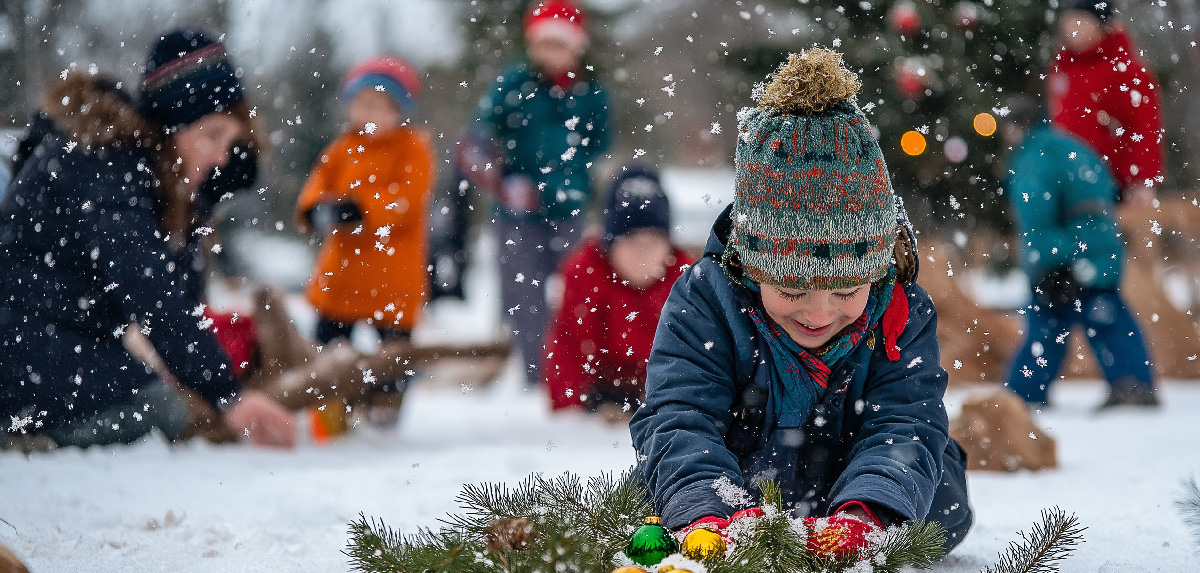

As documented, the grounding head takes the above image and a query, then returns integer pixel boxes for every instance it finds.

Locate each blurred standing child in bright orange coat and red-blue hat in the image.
[296,56,434,423]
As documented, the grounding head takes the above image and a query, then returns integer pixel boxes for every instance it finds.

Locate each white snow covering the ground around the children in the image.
[0,170,1200,573]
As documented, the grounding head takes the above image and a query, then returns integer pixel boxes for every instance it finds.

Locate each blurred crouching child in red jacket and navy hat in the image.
[541,167,691,423]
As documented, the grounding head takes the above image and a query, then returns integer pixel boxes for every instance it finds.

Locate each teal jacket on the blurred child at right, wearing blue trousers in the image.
[1004,123,1124,290]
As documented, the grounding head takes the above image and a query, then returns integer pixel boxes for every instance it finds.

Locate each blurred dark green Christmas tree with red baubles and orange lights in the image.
[725,0,1055,231]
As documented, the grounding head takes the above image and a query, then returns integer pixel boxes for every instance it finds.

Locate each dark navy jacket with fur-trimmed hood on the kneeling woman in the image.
[0,73,239,427]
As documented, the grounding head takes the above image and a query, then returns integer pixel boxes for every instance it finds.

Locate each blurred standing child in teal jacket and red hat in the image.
[456,0,608,385]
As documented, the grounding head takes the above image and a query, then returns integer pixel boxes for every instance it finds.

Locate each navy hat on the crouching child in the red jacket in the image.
[604,165,671,248]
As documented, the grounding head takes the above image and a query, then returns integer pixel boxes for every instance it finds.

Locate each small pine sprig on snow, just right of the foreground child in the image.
[983,506,1087,573]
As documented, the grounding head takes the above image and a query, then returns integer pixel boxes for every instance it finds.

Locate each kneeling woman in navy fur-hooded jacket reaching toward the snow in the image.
[0,30,295,450]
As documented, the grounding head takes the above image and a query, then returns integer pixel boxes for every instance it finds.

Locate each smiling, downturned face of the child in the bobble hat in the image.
[762,284,871,349]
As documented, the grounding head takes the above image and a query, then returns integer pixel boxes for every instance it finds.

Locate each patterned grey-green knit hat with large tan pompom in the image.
[726,48,896,290]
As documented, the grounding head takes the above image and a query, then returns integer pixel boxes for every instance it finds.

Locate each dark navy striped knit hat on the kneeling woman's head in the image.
[138,29,242,132]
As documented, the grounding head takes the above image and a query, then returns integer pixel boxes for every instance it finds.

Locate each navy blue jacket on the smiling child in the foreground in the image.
[630,210,971,547]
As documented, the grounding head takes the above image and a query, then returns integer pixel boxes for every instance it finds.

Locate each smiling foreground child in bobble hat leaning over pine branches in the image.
[630,49,972,554]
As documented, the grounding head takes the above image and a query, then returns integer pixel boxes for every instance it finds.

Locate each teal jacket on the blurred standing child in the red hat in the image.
[468,62,610,219]
